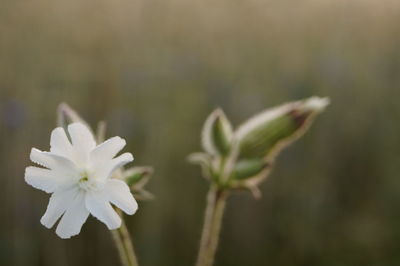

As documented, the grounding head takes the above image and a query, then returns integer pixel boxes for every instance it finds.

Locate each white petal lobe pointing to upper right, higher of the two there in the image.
[90,137,126,166]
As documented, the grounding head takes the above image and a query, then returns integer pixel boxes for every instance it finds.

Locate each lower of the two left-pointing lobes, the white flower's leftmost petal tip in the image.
[25,166,72,193]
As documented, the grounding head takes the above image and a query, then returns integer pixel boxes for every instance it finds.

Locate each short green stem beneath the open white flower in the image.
[111,216,139,266]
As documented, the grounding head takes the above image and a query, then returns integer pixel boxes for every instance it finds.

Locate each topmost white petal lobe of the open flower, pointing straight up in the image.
[68,123,96,165]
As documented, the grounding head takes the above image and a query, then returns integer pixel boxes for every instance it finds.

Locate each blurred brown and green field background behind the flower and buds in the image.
[0,0,400,266]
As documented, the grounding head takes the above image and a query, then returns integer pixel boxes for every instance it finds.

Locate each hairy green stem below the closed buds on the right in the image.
[196,185,228,266]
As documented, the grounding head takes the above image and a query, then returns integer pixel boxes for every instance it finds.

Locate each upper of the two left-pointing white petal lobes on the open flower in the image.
[30,148,79,177]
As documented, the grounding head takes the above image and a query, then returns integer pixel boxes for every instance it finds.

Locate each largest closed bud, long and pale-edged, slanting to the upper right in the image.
[235,97,329,160]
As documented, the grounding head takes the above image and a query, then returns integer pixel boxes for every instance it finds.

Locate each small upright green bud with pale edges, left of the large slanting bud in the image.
[202,109,233,156]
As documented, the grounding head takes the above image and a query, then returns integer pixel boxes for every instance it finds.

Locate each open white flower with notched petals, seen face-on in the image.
[25,123,138,238]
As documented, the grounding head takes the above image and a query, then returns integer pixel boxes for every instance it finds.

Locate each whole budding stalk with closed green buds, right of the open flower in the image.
[189,97,329,266]
